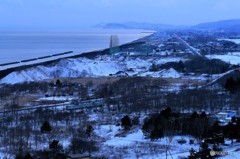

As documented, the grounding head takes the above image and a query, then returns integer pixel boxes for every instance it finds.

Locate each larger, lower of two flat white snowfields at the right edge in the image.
[206,52,240,65]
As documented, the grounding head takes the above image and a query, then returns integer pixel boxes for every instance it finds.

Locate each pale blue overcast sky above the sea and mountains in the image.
[0,0,240,29]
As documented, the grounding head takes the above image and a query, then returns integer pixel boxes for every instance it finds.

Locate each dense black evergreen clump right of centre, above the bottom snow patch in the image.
[142,108,210,140]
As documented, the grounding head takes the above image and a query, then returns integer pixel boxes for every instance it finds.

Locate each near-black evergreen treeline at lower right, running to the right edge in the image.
[142,108,240,159]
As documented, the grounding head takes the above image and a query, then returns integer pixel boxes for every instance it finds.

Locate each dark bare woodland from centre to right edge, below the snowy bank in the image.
[95,77,239,113]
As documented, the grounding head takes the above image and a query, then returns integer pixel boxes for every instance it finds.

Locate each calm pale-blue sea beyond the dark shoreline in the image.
[0,30,149,64]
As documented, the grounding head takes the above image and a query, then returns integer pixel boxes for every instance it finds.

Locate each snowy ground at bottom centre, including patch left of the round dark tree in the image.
[95,125,199,159]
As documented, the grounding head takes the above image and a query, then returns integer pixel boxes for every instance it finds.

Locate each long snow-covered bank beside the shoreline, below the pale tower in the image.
[0,55,184,84]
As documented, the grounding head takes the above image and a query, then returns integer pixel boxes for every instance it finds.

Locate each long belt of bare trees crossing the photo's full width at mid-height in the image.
[0,77,239,113]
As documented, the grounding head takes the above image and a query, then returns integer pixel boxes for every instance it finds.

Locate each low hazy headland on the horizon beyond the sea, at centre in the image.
[94,22,186,30]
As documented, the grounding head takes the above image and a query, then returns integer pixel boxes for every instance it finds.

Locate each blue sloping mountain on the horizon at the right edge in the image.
[192,19,240,32]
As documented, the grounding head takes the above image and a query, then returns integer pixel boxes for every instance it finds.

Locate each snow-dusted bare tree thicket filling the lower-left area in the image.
[0,109,94,157]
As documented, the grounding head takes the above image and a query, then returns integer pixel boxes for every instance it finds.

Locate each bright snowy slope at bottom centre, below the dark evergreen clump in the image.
[104,129,199,159]
